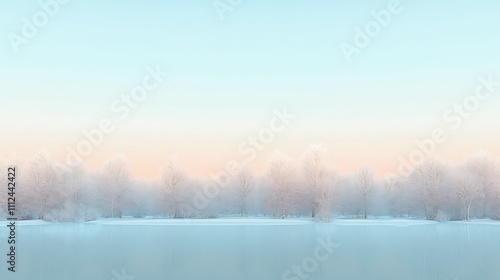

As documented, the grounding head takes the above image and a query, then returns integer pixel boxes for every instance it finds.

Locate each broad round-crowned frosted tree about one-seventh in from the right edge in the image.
[409,158,447,220]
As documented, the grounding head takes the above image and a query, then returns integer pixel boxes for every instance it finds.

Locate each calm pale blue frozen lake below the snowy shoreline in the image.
[0,218,500,280]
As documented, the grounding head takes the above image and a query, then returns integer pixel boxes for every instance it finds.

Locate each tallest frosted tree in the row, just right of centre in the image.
[302,144,328,218]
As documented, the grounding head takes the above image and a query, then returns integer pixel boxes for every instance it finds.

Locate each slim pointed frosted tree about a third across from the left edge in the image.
[161,157,186,218]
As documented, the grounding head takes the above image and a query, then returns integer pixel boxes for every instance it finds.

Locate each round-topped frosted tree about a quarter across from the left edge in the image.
[101,156,130,218]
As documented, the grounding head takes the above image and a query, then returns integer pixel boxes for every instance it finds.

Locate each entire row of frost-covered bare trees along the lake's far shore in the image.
[0,145,500,221]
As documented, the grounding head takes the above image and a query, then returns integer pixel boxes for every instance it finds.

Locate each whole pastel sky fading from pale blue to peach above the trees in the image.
[0,0,500,177]
